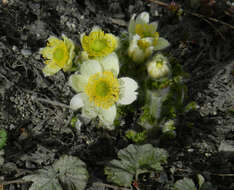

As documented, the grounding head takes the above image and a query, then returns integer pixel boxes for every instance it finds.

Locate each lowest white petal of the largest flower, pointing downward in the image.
[98,105,116,127]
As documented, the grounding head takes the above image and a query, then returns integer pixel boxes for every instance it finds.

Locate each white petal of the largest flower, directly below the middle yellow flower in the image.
[80,59,102,76]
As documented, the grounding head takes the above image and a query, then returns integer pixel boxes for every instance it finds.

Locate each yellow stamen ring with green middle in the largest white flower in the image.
[85,71,119,109]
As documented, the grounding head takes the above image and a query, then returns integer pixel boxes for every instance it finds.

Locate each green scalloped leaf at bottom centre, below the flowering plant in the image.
[105,144,168,187]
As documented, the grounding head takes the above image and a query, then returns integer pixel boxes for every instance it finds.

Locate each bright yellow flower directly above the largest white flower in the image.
[81,27,118,58]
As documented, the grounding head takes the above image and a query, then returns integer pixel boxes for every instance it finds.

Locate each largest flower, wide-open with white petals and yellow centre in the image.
[69,53,138,128]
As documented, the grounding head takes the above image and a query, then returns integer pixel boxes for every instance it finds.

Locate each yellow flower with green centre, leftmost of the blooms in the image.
[40,35,75,76]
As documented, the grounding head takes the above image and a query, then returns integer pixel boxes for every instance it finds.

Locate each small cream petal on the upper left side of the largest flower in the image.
[68,74,88,92]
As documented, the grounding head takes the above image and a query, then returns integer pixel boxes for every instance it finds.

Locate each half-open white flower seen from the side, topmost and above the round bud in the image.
[128,12,170,62]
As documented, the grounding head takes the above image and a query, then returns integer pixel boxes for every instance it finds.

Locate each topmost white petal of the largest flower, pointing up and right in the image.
[99,53,119,77]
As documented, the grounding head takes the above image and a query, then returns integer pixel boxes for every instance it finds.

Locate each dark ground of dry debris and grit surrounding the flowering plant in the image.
[0,0,234,190]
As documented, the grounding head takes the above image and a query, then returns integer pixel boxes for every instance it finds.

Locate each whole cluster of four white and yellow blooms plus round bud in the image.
[40,12,177,129]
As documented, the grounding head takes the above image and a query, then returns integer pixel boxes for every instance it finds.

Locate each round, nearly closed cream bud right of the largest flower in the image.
[147,53,171,79]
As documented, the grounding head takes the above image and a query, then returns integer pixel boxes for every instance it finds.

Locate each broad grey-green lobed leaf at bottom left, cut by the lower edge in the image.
[23,155,88,190]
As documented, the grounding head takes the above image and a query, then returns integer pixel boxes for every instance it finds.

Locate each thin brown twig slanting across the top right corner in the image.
[148,0,234,30]
